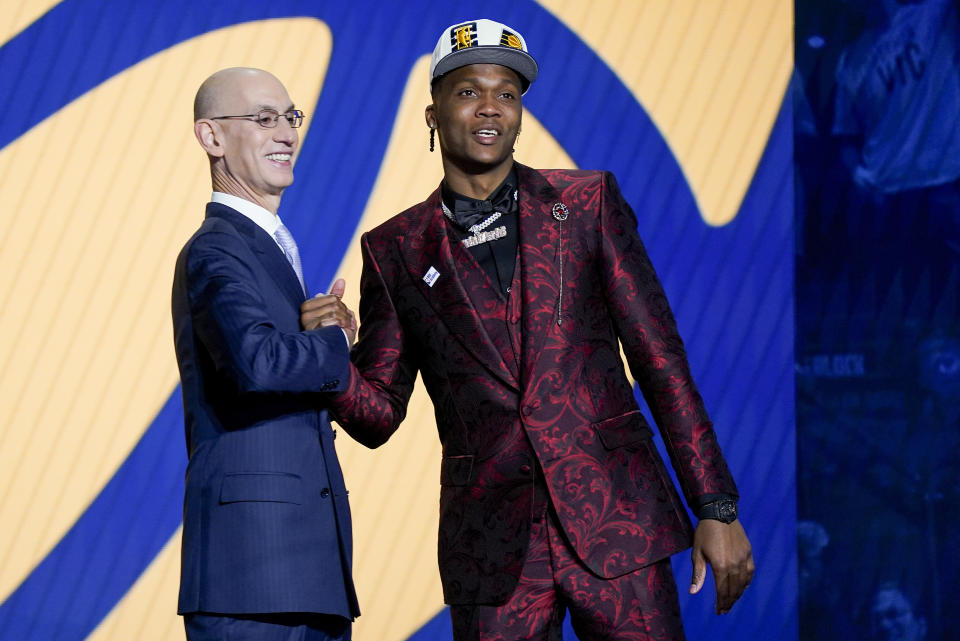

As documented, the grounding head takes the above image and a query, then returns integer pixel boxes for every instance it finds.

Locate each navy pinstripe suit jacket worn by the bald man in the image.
[172,203,359,619]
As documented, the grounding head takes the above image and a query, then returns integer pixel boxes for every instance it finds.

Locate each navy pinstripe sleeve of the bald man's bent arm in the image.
[182,231,349,393]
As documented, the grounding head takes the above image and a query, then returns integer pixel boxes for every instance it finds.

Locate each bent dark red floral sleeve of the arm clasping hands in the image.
[330,234,417,448]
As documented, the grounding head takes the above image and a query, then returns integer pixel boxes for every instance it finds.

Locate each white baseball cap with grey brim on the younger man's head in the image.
[430,18,537,93]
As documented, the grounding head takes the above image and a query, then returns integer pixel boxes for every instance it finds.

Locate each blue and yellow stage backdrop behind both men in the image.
[0,0,796,641]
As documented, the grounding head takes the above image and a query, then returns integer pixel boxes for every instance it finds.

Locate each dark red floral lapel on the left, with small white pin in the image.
[397,189,518,388]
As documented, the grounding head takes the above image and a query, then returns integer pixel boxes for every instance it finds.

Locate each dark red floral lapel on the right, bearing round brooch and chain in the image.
[516,163,569,384]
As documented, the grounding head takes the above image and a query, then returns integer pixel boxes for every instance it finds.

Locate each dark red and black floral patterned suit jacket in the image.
[333,165,736,603]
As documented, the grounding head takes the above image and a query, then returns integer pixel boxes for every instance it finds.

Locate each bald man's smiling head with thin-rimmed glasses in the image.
[194,69,300,213]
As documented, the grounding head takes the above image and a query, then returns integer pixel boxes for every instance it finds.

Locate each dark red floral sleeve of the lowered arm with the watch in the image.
[600,172,737,509]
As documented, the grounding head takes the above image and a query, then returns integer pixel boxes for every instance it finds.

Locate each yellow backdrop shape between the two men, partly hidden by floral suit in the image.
[330,56,574,641]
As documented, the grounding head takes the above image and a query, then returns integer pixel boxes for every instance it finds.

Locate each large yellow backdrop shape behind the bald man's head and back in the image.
[0,19,331,608]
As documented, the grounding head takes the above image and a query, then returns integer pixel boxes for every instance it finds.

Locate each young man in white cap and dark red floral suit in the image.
[302,20,753,641]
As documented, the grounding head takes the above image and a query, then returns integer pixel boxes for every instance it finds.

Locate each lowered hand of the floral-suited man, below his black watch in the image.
[690,519,754,614]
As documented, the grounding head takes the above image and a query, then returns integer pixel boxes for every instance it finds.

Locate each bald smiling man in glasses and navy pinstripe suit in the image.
[173,68,360,641]
